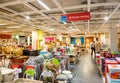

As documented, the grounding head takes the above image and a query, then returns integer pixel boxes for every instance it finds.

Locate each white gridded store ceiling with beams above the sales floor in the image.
[0,0,120,35]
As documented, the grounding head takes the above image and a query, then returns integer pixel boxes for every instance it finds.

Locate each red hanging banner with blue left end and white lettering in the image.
[61,12,90,22]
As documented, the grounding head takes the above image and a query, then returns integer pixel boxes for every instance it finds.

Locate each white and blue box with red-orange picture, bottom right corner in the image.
[106,64,120,83]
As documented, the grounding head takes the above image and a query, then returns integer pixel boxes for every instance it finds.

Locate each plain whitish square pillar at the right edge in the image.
[109,27,118,52]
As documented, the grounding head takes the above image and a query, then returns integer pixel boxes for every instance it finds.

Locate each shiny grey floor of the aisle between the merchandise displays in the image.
[72,53,103,83]
